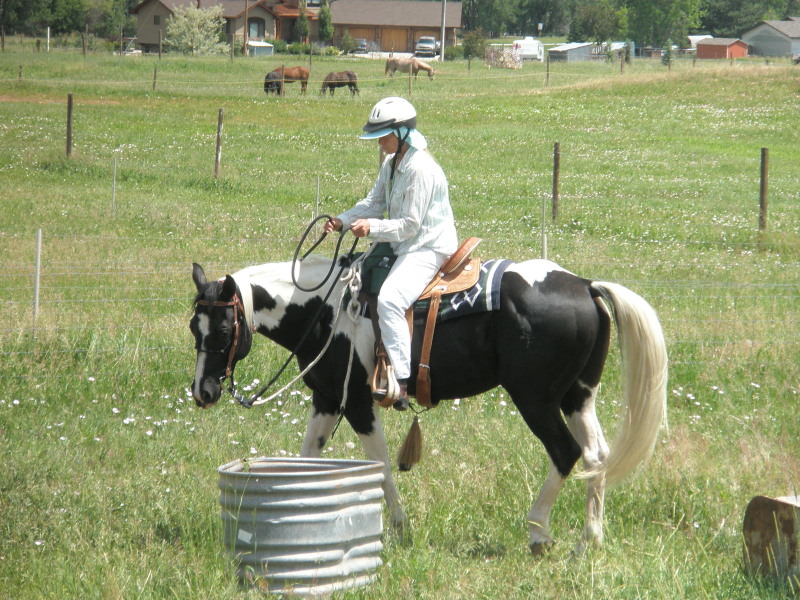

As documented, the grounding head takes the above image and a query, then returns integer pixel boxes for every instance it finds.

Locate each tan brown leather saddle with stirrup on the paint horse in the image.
[360,237,483,407]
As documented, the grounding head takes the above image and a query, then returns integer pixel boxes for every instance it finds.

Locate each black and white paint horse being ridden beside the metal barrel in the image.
[190,255,667,553]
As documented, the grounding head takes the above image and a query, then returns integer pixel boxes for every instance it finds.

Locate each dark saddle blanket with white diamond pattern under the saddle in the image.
[414,259,514,321]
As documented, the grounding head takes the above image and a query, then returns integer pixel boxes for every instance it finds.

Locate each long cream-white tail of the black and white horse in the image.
[585,281,667,485]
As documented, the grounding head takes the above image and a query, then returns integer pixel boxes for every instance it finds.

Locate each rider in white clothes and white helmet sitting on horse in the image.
[325,97,458,410]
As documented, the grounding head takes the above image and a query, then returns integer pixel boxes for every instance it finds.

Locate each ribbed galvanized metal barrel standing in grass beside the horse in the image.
[219,458,383,596]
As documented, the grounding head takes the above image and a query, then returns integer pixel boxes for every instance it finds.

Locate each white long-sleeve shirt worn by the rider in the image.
[339,147,458,256]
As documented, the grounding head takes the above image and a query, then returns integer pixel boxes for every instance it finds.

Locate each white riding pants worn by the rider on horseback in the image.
[378,248,448,379]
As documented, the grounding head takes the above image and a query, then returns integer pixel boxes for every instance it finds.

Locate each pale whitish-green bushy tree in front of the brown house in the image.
[164,5,230,55]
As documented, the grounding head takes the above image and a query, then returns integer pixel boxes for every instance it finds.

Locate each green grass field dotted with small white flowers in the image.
[0,41,800,600]
